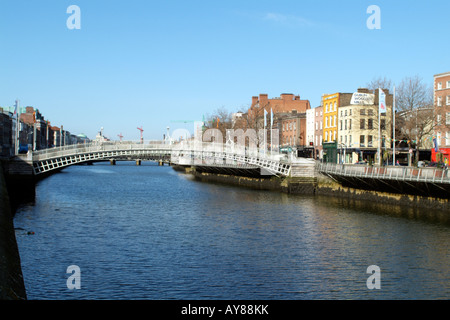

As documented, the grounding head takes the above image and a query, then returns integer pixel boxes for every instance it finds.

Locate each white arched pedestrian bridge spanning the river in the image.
[32,141,298,176]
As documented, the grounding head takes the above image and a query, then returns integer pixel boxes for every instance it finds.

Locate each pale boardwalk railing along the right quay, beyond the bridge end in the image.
[317,163,450,183]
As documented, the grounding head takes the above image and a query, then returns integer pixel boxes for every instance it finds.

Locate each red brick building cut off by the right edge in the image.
[432,72,450,163]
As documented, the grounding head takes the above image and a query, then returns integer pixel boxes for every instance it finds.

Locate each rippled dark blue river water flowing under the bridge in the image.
[14,162,450,300]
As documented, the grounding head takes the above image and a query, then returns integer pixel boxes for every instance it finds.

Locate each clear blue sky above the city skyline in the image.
[0,0,450,140]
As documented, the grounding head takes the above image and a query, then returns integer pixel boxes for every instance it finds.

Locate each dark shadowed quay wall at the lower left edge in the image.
[0,162,26,300]
